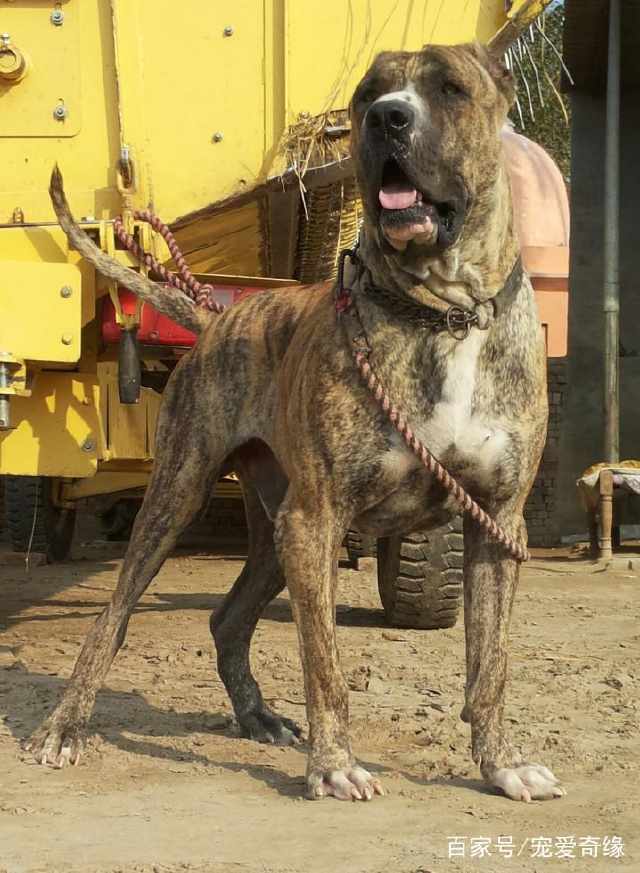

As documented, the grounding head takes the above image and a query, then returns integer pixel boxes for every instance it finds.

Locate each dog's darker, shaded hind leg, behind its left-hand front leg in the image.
[211,471,300,745]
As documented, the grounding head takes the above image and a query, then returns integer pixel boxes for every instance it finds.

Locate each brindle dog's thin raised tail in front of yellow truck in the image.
[49,164,211,333]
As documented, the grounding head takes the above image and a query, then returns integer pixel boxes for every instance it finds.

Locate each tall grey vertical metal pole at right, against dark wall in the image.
[603,0,620,463]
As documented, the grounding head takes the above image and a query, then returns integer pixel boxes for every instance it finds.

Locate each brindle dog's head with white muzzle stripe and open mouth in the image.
[350,44,514,264]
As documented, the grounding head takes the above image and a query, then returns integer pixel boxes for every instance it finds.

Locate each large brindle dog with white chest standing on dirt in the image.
[30,45,563,801]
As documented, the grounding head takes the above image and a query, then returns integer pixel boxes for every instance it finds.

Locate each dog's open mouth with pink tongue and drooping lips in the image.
[378,158,455,251]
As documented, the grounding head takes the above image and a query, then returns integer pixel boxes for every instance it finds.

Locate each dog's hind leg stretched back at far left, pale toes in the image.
[25,367,227,766]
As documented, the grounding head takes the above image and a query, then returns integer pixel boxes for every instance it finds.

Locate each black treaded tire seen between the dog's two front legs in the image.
[378,518,464,629]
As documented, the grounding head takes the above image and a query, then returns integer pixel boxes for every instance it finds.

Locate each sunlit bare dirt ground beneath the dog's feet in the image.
[0,532,640,873]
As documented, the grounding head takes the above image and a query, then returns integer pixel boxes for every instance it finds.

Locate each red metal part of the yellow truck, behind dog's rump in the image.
[102,285,265,348]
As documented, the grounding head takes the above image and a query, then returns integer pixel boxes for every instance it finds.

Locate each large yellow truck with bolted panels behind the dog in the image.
[0,0,545,624]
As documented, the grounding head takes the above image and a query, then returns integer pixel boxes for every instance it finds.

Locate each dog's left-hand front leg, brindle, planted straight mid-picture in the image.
[276,495,383,800]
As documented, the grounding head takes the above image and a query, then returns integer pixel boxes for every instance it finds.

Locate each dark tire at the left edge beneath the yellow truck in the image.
[4,476,76,563]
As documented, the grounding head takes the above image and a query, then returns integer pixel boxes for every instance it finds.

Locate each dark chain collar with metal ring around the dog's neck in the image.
[335,243,523,340]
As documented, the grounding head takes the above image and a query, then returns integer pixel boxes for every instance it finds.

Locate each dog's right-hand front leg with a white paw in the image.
[462,508,564,801]
